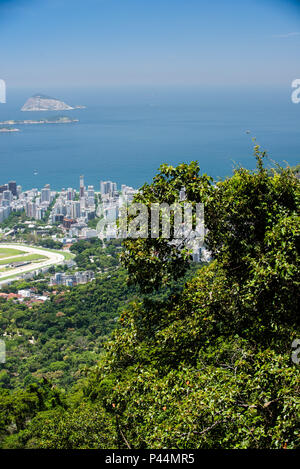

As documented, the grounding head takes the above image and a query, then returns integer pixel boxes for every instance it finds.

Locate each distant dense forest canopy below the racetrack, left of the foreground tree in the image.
[0,270,133,389]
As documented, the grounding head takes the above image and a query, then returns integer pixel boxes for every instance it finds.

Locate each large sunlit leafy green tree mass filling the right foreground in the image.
[86,152,299,448]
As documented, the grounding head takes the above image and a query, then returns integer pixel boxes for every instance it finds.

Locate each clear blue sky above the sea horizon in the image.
[0,0,300,87]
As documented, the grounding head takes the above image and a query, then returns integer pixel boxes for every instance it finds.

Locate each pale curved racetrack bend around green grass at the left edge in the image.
[0,243,65,285]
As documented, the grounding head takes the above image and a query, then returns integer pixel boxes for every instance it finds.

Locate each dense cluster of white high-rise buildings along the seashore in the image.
[0,175,137,229]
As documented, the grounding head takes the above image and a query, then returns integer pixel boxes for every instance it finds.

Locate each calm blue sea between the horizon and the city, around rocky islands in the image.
[0,84,300,190]
